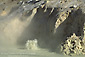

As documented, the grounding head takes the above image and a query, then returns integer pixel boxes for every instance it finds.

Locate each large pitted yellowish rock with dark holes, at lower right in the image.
[61,24,85,55]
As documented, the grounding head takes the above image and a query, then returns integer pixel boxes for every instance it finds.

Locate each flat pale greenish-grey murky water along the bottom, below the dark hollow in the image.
[0,48,84,57]
